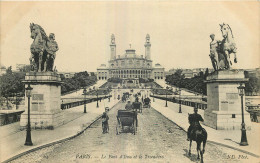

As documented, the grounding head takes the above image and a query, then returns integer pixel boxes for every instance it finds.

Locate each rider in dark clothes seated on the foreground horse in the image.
[187,107,204,141]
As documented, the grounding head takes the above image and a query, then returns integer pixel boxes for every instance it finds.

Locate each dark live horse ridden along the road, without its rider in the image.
[189,115,208,163]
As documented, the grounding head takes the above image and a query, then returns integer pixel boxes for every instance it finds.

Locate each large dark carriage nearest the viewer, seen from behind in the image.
[116,110,137,135]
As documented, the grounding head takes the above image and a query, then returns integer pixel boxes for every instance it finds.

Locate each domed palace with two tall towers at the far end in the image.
[97,34,165,83]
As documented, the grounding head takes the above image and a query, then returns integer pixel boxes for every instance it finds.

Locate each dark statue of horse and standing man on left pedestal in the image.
[30,23,58,72]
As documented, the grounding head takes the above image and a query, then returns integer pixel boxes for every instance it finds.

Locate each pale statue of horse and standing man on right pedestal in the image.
[209,23,237,71]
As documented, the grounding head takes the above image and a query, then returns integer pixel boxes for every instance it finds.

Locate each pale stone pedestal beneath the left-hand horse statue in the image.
[20,72,64,129]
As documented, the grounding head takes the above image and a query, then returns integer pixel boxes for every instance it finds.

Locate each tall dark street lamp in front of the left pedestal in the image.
[24,84,33,146]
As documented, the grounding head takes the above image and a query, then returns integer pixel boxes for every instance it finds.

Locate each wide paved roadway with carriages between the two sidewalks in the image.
[13,103,249,163]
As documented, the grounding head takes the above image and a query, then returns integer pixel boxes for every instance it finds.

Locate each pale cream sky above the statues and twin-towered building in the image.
[0,1,260,72]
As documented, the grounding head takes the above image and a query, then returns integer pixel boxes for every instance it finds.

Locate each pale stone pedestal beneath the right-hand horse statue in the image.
[204,70,251,130]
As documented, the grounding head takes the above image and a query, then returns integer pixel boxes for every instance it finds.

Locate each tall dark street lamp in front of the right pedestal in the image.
[237,83,248,146]
